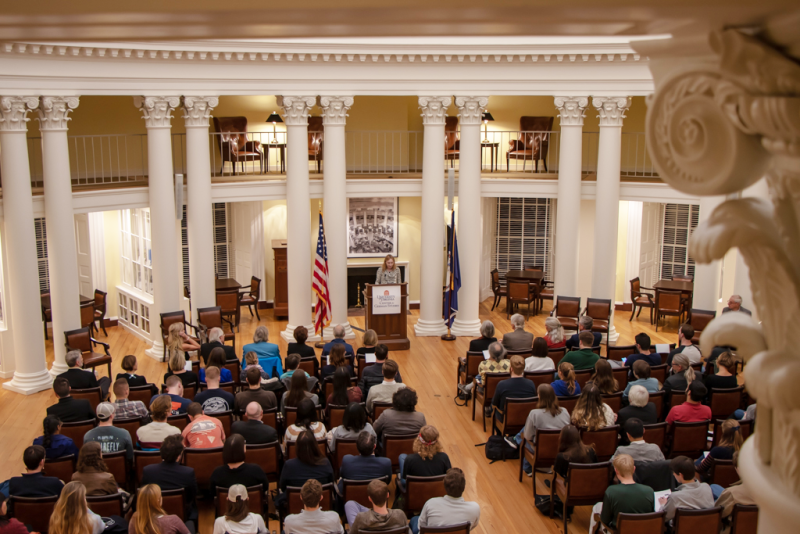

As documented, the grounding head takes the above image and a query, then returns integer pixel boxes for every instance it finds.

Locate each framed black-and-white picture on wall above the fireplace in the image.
[347,197,398,258]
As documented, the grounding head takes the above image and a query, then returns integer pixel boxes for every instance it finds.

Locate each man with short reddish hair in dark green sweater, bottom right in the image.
[589,454,655,532]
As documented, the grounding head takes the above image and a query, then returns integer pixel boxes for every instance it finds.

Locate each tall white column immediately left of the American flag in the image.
[278,96,318,341]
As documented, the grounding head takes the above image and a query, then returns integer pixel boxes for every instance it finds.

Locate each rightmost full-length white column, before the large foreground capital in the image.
[592,96,631,344]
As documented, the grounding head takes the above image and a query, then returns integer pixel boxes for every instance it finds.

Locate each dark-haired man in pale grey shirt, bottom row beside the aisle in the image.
[408,467,481,534]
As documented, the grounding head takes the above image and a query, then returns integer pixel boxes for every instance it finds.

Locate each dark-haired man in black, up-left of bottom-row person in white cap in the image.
[141,438,198,525]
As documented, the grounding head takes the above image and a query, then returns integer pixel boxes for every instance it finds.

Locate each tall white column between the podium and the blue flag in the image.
[414,96,451,336]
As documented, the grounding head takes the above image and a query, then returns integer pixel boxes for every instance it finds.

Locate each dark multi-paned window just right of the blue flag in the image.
[492,198,553,279]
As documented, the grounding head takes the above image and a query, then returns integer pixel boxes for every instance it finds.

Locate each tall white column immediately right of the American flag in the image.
[319,96,356,339]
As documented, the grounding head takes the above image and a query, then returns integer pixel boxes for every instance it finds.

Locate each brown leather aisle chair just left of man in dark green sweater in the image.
[550,462,614,532]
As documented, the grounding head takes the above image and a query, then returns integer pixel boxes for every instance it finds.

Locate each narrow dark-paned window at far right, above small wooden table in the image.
[661,204,700,279]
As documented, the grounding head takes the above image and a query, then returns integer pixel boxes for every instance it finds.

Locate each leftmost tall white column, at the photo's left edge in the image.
[0,96,52,395]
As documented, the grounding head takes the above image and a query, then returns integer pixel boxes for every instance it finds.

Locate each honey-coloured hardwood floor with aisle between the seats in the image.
[0,300,678,534]
